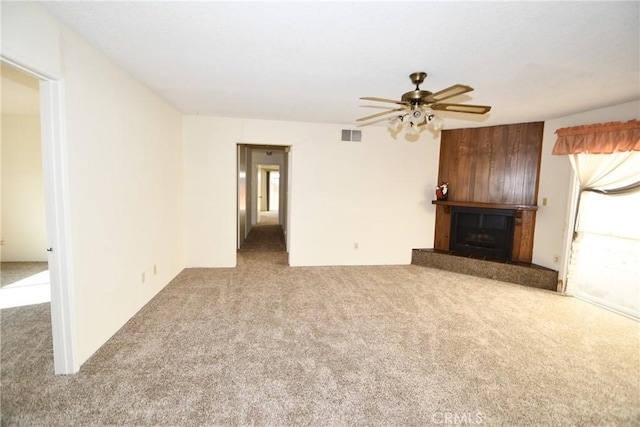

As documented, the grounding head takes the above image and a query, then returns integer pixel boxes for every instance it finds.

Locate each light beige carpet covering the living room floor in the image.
[1,252,640,426]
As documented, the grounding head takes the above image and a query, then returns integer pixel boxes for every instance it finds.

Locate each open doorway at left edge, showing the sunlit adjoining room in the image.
[0,62,51,308]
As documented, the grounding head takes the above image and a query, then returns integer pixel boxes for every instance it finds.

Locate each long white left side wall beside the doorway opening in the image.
[2,2,184,363]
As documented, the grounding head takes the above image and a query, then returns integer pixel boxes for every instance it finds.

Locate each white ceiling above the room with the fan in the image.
[42,1,640,128]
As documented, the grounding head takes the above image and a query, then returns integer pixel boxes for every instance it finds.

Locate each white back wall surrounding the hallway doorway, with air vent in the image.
[184,116,439,267]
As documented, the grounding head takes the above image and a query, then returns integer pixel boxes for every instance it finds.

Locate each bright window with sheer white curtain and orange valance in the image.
[554,120,640,319]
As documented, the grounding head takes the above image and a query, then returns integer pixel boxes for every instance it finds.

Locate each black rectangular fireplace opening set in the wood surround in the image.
[449,206,515,261]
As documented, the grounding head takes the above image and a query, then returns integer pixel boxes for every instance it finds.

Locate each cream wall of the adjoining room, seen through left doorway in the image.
[1,115,47,262]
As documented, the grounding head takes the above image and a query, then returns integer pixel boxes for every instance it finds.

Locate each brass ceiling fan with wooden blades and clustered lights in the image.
[356,71,491,134]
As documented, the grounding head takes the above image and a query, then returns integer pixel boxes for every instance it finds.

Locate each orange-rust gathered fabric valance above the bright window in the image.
[552,120,640,155]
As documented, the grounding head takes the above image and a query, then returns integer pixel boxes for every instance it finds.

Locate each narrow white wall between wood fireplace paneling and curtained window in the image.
[533,101,640,280]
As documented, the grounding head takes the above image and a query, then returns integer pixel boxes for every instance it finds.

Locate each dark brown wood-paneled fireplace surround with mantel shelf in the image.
[433,122,544,262]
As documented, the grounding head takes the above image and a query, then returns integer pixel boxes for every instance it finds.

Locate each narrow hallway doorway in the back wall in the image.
[237,144,290,251]
